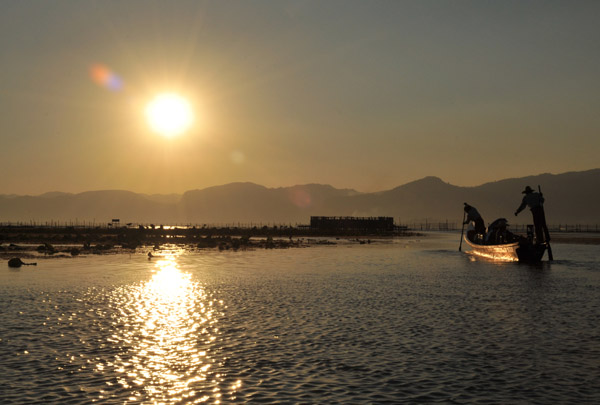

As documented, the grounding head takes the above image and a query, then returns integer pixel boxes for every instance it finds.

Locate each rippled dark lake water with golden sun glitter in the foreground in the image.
[0,234,600,404]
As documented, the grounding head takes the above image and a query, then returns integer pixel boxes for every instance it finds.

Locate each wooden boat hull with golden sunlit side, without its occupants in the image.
[464,235,546,263]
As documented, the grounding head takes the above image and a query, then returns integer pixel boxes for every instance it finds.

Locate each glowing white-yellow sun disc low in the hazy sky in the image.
[146,93,194,138]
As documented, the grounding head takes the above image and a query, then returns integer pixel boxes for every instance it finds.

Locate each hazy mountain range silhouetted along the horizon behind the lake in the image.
[0,169,600,225]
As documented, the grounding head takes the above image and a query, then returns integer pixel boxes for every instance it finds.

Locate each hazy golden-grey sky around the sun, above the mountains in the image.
[0,0,600,194]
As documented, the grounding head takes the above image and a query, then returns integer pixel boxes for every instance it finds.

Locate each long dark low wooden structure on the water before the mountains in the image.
[310,217,394,234]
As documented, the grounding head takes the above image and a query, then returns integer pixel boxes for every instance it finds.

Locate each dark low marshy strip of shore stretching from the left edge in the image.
[0,226,423,259]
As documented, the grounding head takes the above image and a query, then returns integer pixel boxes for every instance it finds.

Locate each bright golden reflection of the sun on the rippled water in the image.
[96,255,232,403]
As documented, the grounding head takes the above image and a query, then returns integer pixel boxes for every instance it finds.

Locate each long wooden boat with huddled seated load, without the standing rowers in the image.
[464,218,546,263]
